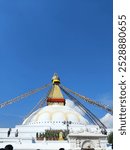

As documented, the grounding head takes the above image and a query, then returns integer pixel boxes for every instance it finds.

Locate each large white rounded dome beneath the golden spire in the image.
[23,105,88,125]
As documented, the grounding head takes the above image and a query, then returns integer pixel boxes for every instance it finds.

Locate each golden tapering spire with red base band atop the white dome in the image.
[47,73,65,105]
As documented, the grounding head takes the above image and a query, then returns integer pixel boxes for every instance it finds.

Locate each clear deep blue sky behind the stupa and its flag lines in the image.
[0,0,112,127]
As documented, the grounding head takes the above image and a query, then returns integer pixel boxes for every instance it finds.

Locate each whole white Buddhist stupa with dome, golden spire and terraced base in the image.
[0,74,111,150]
